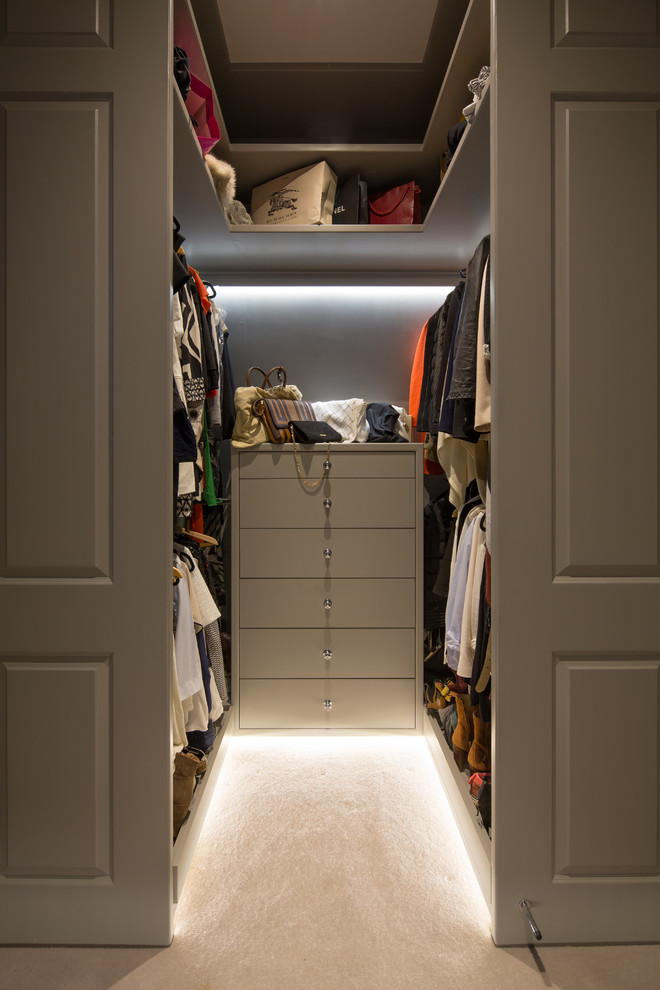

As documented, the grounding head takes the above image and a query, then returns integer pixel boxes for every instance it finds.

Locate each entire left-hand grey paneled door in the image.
[0,0,172,944]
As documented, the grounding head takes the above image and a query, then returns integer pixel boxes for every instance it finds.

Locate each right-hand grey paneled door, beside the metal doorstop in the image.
[492,0,660,944]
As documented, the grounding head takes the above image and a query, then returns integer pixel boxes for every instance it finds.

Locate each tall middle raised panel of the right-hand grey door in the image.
[552,98,660,577]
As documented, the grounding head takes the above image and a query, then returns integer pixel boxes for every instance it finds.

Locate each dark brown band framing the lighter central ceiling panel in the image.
[192,0,468,144]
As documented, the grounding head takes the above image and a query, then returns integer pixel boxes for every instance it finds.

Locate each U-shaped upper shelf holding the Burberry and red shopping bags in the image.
[174,0,490,282]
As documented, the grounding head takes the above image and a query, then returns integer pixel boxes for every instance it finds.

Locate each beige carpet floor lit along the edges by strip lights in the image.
[0,736,660,990]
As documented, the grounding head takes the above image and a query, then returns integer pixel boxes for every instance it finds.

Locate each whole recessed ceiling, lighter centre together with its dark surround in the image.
[192,0,468,145]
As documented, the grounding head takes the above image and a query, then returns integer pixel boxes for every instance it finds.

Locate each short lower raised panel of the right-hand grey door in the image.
[553,653,660,879]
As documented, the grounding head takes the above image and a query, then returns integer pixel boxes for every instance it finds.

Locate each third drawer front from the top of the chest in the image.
[240,527,415,578]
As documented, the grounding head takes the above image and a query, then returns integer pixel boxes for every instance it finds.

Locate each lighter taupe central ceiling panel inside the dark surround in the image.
[217,0,438,64]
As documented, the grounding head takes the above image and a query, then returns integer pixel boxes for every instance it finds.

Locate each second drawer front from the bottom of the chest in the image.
[239,629,415,678]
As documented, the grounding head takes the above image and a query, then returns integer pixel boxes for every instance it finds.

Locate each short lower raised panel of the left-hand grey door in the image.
[0,656,112,882]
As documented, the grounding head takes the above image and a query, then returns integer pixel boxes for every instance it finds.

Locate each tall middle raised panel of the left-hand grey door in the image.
[0,96,112,578]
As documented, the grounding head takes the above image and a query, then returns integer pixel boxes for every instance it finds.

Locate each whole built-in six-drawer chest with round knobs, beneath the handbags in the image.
[232,444,423,730]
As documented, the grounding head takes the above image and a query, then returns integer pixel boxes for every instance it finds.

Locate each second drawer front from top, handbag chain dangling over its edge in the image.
[239,478,416,529]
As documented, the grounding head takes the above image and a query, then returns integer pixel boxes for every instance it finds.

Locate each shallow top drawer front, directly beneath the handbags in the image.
[239,444,419,480]
